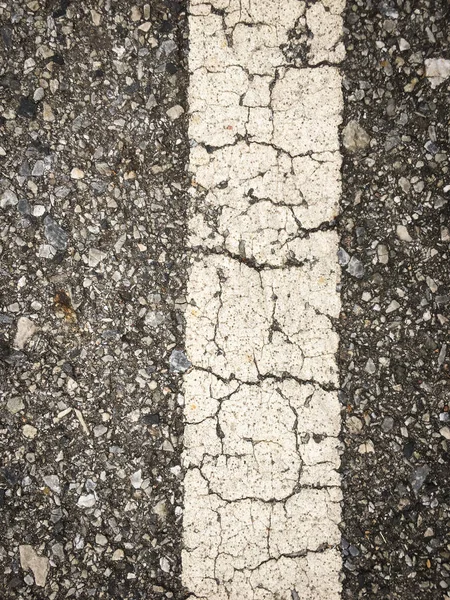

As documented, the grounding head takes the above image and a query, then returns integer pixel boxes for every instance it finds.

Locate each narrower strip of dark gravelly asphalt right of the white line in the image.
[340,0,450,600]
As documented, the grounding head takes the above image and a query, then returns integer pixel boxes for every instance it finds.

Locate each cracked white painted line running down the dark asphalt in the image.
[183,0,344,600]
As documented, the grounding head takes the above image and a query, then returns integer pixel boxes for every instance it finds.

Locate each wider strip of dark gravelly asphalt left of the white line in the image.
[0,0,187,600]
